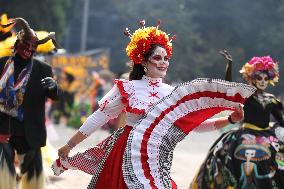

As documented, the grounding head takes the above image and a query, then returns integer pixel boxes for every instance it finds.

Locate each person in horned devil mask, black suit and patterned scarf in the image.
[0,18,59,189]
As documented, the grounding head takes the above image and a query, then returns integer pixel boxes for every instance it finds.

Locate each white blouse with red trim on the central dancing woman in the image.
[79,76,173,136]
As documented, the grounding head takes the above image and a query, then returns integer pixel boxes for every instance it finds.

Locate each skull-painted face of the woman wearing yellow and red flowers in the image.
[146,46,169,78]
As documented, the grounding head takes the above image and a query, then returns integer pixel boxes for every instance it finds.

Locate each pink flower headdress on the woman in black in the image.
[240,56,279,86]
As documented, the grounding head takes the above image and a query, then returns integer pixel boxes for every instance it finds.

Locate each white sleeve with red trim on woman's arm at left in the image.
[79,80,127,136]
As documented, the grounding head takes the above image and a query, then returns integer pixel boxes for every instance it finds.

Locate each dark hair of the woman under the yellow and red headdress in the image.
[129,44,164,81]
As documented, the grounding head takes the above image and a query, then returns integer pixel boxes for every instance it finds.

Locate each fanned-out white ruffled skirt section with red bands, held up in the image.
[123,79,255,189]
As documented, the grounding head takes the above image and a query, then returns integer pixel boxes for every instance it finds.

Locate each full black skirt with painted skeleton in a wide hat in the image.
[190,124,284,189]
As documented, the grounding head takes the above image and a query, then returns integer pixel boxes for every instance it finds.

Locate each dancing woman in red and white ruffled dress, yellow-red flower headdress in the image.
[52,20,255,189]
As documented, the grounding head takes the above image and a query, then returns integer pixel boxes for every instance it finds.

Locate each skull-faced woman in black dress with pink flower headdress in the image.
[190,51,284,189]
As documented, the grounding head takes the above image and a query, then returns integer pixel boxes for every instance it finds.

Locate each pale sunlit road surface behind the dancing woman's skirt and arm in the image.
[45,126,222,189]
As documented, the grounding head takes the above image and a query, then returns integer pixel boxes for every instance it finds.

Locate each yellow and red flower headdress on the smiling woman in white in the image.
[124,20,176,64]
